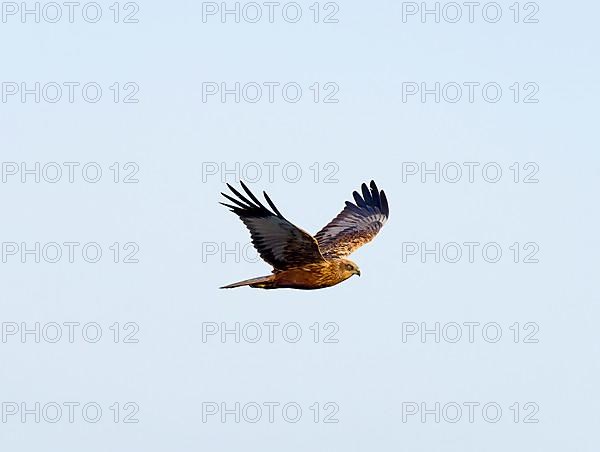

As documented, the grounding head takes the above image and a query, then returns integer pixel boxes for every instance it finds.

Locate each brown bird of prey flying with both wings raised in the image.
[220,181,390,290]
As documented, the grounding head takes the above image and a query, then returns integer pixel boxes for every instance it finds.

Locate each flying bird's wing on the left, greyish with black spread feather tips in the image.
[220,182,325,270]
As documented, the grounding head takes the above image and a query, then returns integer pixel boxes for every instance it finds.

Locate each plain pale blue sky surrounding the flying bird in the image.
[0,1,600,452]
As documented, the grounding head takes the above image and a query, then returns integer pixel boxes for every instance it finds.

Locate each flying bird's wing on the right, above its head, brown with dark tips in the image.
[315,181,390,259]
